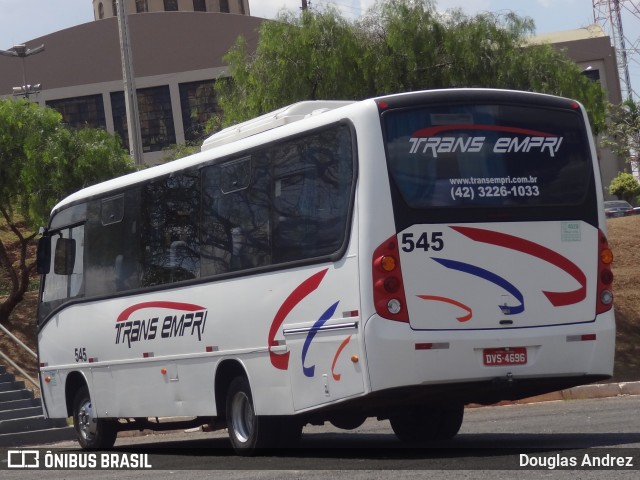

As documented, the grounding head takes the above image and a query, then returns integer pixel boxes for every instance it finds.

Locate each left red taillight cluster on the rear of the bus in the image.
[373,235,409,322]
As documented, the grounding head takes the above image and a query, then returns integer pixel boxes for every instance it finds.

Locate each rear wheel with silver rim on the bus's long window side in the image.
[226,377,278,456]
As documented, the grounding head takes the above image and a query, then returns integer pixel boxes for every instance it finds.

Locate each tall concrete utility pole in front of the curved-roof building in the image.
[117,0,143,165]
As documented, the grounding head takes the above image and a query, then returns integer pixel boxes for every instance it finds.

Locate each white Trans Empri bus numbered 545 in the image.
[38,89,615,454]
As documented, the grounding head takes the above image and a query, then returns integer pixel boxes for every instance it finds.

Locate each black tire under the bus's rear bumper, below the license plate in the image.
[389,406,441,444]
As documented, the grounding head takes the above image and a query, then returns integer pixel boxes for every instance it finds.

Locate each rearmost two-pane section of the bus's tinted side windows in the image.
[201,125,354,276]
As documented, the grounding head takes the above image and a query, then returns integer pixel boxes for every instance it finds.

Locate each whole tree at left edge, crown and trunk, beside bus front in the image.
[0,99,134,323]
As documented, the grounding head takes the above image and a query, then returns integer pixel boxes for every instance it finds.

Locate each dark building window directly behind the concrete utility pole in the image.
[111,85,176,152]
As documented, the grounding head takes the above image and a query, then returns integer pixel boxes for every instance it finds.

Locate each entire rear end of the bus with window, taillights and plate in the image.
[365,90,615,403]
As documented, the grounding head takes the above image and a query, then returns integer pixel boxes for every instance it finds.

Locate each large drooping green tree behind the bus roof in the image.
[216,0,605,133]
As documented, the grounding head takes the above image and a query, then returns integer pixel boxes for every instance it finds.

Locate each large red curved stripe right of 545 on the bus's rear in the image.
[451,227,587,307]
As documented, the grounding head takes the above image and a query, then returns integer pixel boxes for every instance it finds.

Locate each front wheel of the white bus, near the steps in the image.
[73,385,118,450]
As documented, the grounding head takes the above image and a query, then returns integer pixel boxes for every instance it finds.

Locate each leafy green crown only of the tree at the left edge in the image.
[0,99,134,227]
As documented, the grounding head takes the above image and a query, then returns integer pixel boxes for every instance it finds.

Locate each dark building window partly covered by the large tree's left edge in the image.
[180,80,220,142]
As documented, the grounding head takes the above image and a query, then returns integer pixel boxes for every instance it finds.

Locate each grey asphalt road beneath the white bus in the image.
[2,396,640,480]
